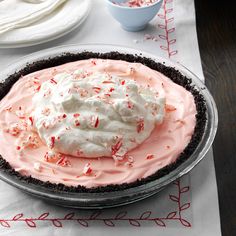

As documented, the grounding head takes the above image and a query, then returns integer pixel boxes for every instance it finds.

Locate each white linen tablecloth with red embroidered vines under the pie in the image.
[0,0,221,236]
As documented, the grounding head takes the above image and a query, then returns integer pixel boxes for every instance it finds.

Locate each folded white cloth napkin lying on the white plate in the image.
[0,0,67,34]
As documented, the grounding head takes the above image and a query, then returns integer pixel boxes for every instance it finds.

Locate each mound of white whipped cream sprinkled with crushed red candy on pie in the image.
[32,70,165,160]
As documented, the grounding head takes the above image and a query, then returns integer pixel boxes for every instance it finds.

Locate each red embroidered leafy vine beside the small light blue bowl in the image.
[157,0,178,58]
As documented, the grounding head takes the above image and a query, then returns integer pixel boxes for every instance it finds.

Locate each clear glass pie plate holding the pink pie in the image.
[0,44,218,209]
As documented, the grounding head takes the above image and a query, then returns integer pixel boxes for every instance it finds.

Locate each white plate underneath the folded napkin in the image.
[0,0,91,48]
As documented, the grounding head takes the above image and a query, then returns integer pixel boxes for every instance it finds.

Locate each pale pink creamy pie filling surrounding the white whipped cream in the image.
[0,59,196,188]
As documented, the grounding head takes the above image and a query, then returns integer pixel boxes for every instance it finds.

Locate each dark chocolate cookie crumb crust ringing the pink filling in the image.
[0,51,207,193]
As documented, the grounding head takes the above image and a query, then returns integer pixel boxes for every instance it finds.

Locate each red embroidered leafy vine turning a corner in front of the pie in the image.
[0,180,191,228]
